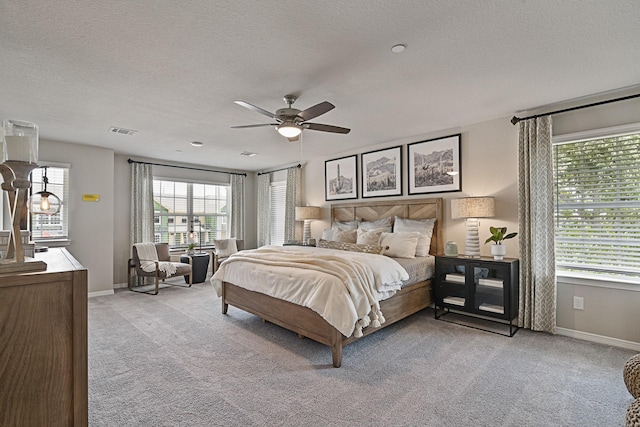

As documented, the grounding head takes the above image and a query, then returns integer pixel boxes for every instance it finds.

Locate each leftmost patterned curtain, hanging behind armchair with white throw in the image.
[130,163,154,247]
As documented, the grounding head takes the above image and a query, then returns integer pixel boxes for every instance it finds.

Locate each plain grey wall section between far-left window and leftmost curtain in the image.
[39,139,114,292]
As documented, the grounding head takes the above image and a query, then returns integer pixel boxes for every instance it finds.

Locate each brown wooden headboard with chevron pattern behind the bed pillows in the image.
[331,198,444,255]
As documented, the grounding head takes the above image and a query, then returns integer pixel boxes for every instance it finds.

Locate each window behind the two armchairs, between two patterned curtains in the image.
[153,179,230,246]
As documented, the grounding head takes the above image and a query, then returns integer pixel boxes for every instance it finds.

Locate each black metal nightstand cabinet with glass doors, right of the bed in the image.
[435,256,520,336]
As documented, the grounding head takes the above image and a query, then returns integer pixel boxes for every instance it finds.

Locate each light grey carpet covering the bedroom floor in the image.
[89,282,633,426]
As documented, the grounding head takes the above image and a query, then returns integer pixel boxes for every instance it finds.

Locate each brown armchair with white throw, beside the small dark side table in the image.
[127,243,193,295]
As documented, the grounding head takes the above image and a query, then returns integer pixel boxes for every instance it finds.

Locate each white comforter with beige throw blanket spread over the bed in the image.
[211,246,409,337]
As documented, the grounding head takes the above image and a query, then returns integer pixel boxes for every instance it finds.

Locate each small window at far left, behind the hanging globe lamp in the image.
[30,162,70,244]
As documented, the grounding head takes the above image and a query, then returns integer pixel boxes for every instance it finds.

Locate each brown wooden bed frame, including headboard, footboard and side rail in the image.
[222,198,444,368]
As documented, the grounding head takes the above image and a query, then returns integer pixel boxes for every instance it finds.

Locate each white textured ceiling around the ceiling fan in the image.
[0,0,640,171]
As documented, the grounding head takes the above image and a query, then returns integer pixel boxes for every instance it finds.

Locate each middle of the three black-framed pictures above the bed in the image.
[360,146,402,198]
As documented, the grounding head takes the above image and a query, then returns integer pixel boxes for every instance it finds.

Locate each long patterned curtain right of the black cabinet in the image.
[518,116,556,333]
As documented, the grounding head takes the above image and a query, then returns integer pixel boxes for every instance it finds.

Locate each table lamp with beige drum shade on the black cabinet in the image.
[451,197,495,258]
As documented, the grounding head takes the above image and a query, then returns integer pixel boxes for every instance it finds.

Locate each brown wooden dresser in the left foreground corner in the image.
[0,248,88,426]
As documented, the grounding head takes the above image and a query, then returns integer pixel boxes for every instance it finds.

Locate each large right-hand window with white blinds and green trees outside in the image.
[553,126,640,283]
